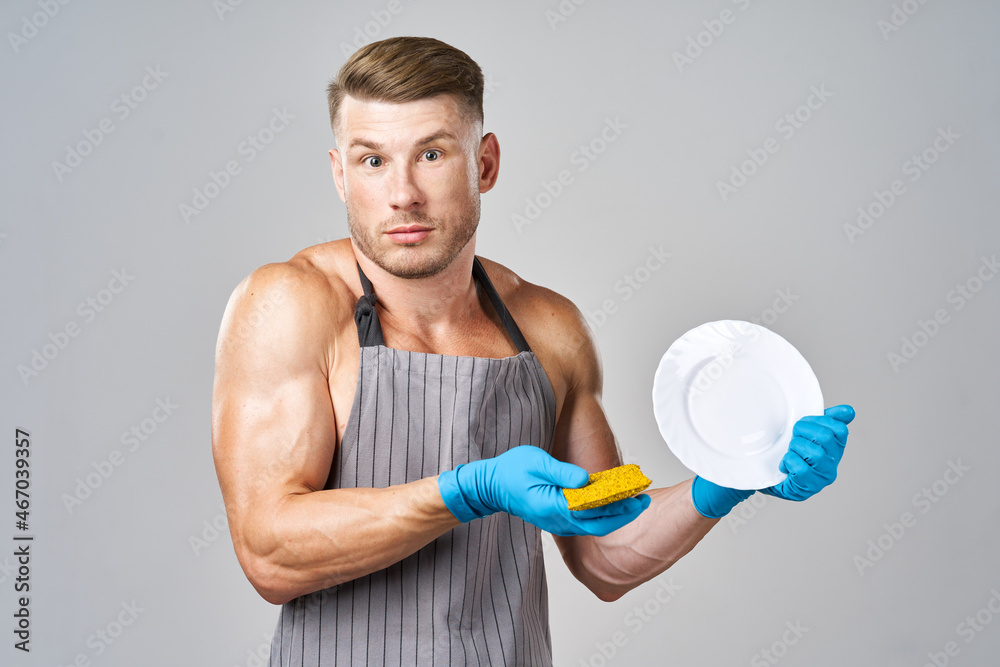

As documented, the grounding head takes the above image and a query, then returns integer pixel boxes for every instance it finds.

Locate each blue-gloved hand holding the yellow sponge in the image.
[438,445,650,535]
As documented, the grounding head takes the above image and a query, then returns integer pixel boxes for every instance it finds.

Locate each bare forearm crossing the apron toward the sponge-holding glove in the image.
[234,477,459,604]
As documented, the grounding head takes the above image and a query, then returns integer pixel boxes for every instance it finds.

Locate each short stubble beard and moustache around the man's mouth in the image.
[347,196,480,280]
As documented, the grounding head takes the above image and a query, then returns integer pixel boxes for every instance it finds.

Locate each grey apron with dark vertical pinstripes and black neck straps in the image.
[270,258,555,667]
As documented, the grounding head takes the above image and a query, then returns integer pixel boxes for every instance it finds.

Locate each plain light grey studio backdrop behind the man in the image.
[0,0,1000,667]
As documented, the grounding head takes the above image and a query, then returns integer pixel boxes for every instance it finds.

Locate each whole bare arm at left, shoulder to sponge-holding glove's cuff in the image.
[212,264,459,604]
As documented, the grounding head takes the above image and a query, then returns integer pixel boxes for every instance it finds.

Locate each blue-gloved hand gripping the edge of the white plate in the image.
[691,405,854,519]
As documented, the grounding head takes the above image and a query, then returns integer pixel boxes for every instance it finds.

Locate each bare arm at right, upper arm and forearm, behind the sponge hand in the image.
[553,302,718,601]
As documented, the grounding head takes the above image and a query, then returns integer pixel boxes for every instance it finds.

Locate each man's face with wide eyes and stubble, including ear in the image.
[330,95,499,278]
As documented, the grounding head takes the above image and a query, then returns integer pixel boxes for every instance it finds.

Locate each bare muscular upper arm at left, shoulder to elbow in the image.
[212,268,336,540]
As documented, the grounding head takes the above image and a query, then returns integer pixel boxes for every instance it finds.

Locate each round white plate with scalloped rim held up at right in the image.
[653,320,823,489]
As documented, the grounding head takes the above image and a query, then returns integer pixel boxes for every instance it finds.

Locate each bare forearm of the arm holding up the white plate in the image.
[556,480,718,601]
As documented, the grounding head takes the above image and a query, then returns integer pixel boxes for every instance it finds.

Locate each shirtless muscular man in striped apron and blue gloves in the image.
[213,37,853,665]
